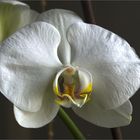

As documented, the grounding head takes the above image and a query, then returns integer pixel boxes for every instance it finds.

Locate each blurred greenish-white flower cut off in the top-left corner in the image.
[0,0,38,42]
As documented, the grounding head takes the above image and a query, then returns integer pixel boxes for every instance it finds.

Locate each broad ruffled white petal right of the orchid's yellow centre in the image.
[67,23,140,109]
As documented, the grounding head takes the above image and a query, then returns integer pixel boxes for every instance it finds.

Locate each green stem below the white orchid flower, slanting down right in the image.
[58,107,86,140]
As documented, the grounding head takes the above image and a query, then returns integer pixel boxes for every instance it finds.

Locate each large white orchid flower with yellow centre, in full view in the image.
[0,9,140,128]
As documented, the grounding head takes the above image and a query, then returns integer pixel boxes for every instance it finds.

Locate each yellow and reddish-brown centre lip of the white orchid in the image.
[53,66,93,107]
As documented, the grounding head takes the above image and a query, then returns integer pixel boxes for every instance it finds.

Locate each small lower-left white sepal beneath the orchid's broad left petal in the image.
[14,88,59,128]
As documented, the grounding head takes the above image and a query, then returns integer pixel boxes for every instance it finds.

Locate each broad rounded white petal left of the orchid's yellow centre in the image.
[0,22,61,112]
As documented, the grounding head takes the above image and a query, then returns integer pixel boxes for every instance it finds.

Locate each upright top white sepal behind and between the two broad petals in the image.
[38,9,82,64]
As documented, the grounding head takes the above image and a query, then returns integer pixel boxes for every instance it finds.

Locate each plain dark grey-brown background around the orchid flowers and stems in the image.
[0,0,140,139]
